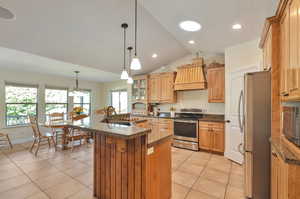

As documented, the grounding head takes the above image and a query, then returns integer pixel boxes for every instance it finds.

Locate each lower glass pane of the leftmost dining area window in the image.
[6,104,37,126]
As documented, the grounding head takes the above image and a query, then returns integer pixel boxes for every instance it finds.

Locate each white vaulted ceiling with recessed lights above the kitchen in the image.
[0,0,278,81]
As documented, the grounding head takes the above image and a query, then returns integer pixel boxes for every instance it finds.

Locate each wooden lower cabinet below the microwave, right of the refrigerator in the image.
[271,148,300,199]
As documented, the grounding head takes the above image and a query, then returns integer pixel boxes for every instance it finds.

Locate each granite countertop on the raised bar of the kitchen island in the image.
[44,121,151,139]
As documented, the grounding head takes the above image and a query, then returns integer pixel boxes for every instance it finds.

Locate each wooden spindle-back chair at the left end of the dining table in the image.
[29,116,55,155]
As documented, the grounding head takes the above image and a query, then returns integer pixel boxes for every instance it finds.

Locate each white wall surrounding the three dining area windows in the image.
[0,69,102,142]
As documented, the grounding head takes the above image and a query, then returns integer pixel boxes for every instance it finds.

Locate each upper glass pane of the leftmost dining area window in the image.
[5,85,37,103]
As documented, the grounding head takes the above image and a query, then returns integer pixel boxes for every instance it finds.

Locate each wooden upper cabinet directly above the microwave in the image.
[280,0,300,101]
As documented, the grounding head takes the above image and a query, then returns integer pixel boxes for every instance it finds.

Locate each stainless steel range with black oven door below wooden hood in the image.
[173,109,203,151]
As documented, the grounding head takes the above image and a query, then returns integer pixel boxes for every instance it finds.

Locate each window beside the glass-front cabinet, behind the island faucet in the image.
[111,90,128,113]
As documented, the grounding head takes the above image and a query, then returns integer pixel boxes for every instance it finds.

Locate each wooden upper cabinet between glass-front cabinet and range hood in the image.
[148,72,176,103]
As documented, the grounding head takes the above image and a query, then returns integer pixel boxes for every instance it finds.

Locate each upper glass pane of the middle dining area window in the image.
[45,89,68,103]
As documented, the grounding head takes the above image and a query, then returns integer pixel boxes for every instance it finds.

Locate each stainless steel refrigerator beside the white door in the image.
[240,71,272,199]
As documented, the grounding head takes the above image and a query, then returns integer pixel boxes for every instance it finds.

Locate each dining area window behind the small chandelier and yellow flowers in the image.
[73,90,91,115]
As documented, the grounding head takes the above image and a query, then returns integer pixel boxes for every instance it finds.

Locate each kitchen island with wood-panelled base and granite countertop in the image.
[52,122,172,199]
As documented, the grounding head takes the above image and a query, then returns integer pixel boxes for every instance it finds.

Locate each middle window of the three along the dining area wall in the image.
[45,88,68,120]
